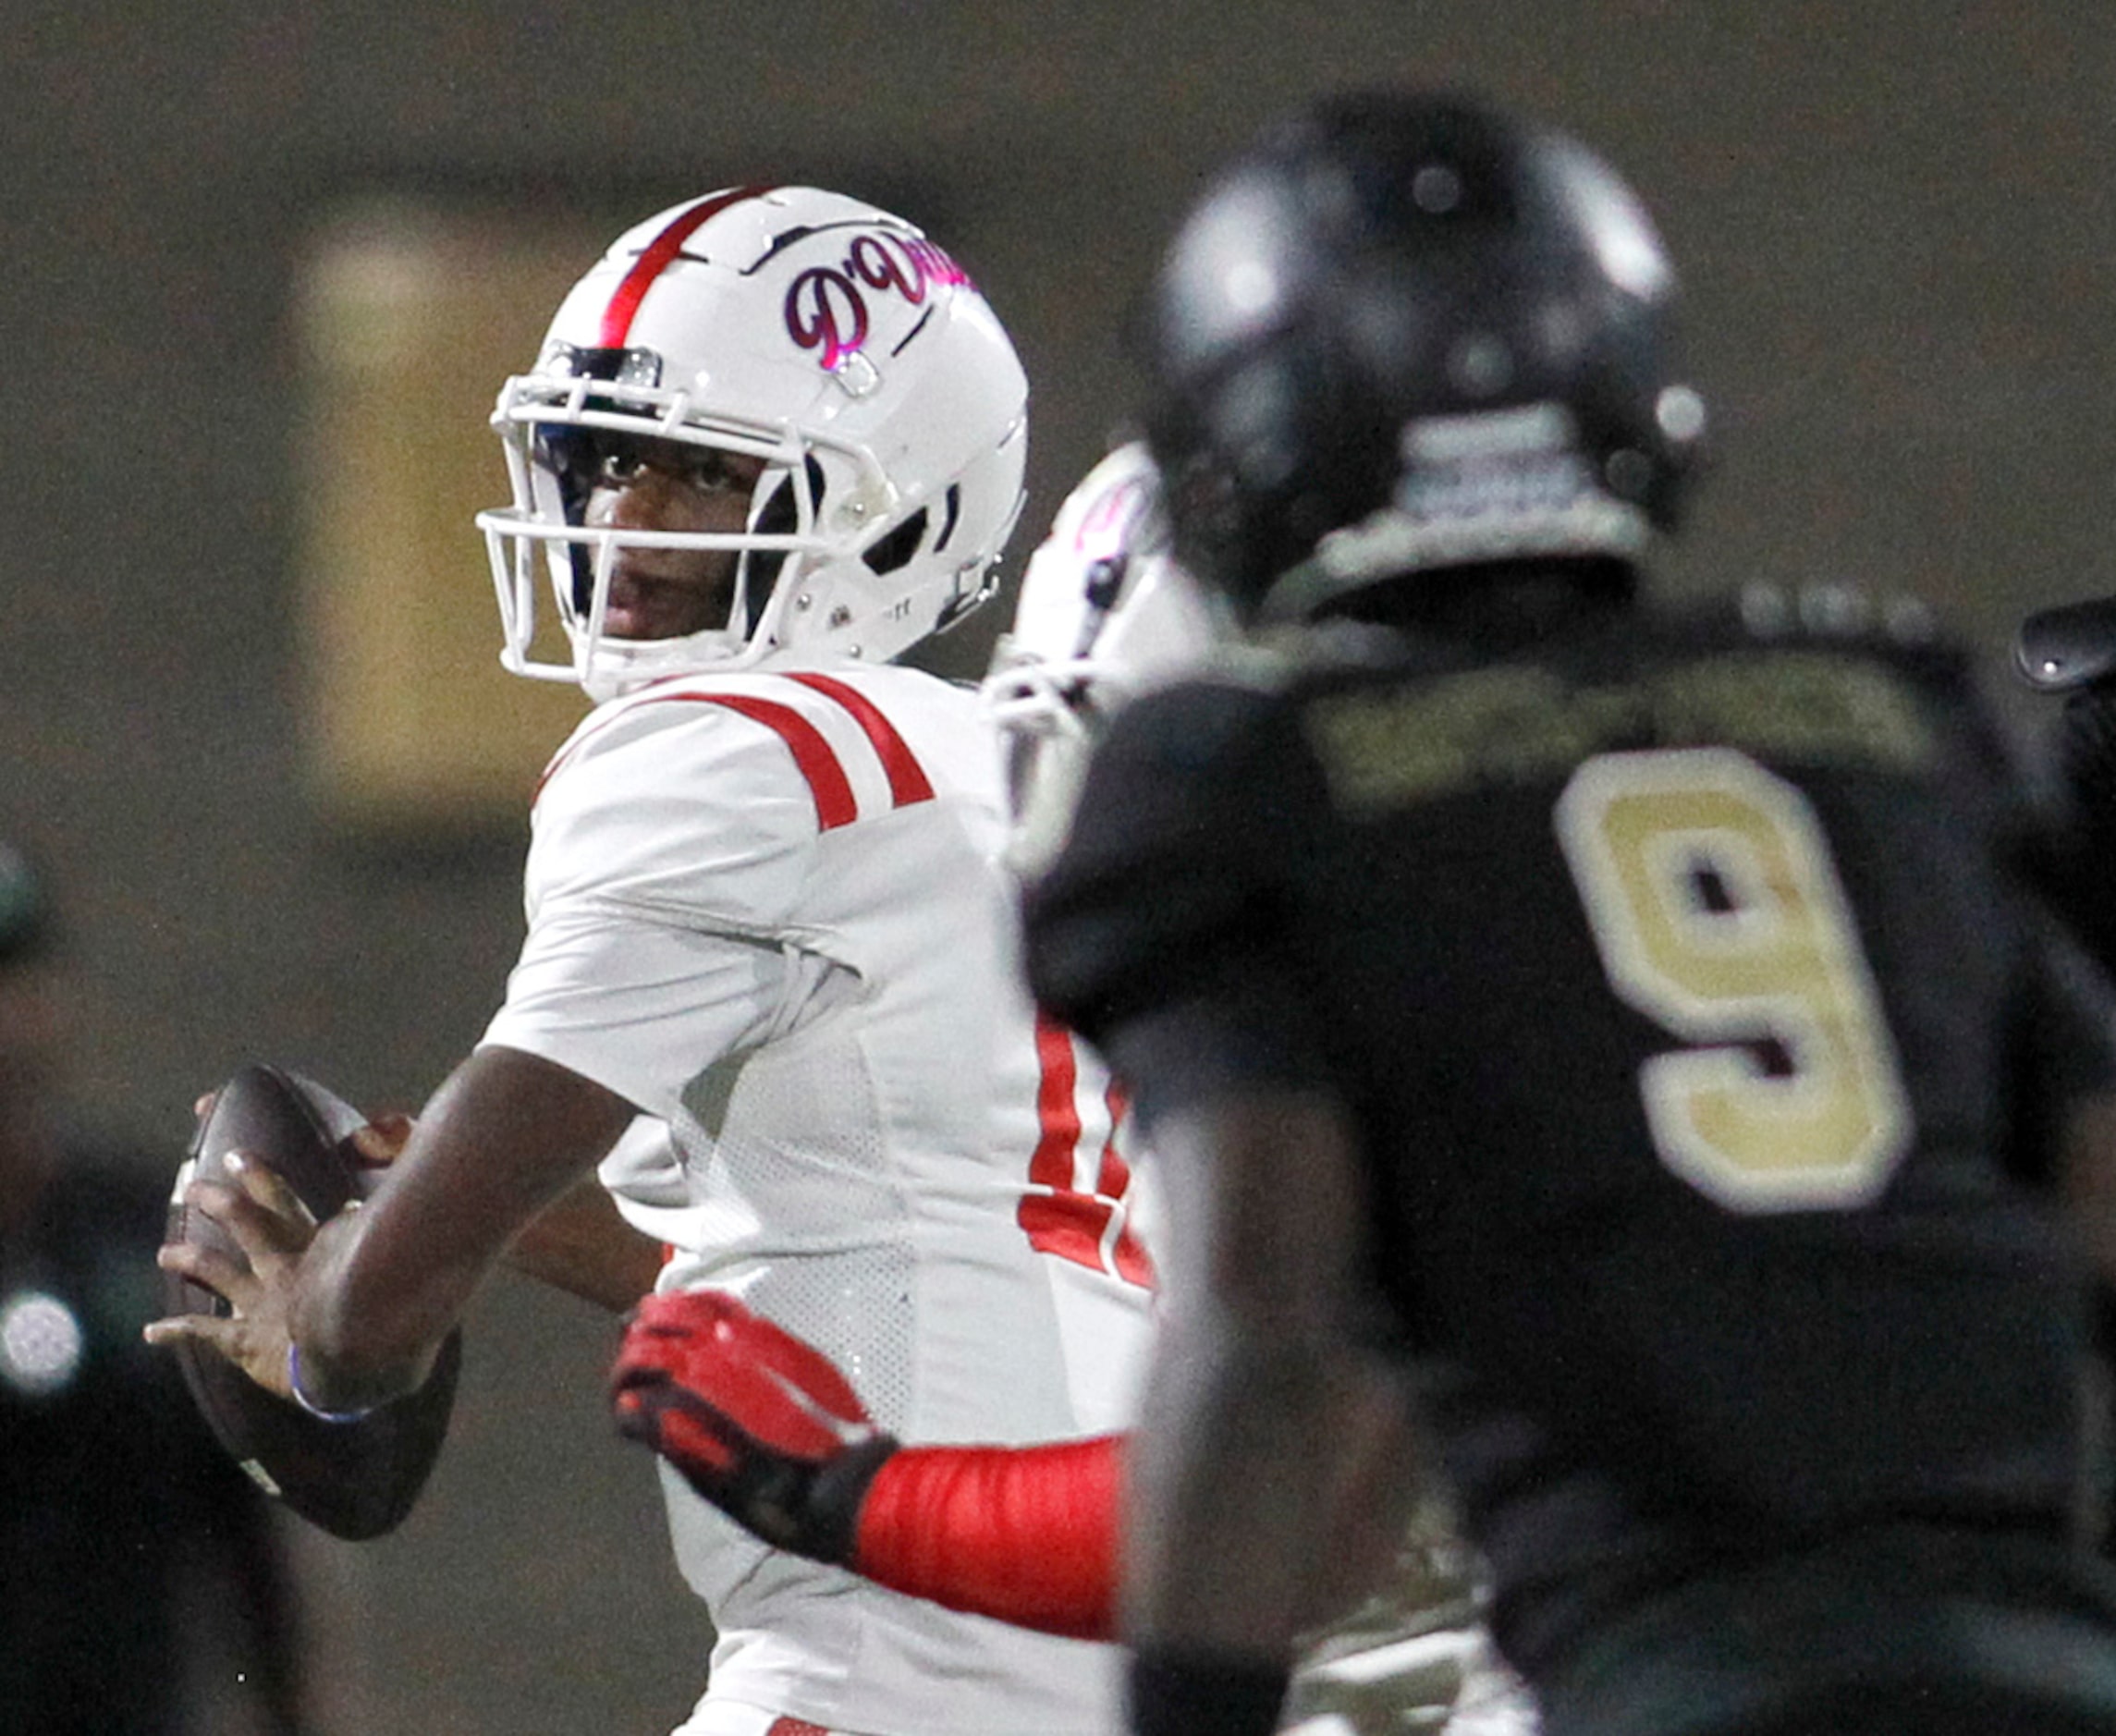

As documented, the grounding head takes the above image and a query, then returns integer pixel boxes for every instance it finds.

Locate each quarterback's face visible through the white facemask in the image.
[588,440,764,640]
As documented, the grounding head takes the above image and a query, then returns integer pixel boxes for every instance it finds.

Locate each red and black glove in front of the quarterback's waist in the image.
[612,1290,898,1567]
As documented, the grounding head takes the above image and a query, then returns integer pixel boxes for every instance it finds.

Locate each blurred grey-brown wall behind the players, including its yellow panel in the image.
[0,0,2116,1736]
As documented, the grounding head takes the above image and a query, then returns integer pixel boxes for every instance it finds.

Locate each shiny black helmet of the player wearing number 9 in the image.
[1138,93,1704,620]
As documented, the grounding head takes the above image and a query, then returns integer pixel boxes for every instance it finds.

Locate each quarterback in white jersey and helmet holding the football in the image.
[161,189,1147,1736]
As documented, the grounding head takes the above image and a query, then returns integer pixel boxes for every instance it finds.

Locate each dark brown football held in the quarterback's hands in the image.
[163,1063,463,1541]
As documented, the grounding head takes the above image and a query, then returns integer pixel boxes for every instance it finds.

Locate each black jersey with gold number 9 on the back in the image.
[1028,588,2116,1666]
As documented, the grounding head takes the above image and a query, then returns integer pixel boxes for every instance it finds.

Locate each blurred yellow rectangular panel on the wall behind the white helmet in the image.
[296,202,607,834]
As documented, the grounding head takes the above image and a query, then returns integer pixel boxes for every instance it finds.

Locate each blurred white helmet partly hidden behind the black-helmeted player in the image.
[984,443,1225,873]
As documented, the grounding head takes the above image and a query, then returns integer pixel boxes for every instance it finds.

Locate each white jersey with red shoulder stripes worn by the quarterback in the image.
[486,663,1151,1736]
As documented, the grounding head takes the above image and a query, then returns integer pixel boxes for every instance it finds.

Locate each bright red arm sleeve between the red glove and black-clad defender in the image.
[850,1436,1123,1639]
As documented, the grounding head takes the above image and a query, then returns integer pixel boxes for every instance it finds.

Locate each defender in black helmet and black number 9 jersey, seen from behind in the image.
[1028,95,2116,1736]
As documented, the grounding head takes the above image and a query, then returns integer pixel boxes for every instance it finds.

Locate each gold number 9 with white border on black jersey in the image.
[1555,747,1911,1211]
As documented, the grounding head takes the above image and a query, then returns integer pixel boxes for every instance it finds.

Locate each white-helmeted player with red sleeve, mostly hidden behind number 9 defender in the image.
[618,443,1536,1736]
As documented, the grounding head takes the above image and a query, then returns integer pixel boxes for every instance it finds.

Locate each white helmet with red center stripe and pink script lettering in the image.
[478,187,1028,699]
